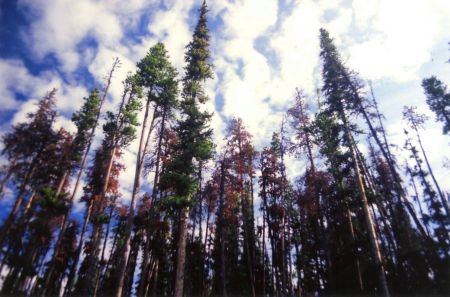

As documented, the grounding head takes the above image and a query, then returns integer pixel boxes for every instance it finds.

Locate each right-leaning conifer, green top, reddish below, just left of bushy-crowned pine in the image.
[66,75,142,294]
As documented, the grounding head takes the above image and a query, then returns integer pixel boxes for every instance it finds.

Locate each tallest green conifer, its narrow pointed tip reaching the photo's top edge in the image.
[161,2,213,297]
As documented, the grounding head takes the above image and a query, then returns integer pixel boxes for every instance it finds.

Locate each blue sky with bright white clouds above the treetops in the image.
[0,0,450,213]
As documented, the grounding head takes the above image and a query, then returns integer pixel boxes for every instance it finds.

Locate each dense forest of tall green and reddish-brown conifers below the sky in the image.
[0,2,450,297]
